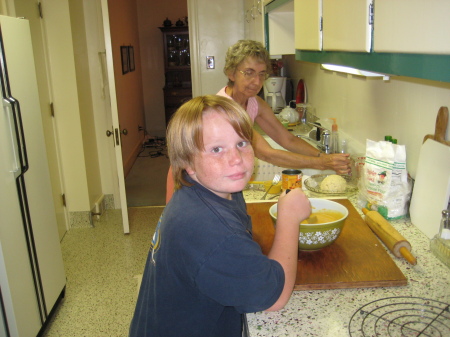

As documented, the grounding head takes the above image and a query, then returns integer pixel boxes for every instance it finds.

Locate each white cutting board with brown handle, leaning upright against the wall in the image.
[409,107,450,239]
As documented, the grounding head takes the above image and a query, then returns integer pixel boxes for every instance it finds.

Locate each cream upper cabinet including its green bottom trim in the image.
[295,0,450,82]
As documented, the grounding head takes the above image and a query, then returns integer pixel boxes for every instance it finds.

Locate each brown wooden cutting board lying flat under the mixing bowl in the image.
[247,199,408,290]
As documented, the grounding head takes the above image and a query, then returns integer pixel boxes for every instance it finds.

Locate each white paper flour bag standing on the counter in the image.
[358,139,411,219]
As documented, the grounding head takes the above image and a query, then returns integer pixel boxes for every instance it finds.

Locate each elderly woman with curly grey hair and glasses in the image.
[217,40,350,174]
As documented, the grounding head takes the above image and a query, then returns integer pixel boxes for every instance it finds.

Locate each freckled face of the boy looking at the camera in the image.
[186,111,254,199]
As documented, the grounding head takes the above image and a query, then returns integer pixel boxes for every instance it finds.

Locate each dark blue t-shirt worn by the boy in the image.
[130,183,284,337]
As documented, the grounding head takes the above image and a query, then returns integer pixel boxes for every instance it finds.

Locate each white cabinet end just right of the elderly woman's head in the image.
[264,0,295,58]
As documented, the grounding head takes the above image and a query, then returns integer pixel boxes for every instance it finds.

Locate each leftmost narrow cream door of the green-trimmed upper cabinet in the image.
[294,0,322,50]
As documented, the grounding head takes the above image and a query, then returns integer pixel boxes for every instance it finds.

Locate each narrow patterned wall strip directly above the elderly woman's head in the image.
[244,0,267,45]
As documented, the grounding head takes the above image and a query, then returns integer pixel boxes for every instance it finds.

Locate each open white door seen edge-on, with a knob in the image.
[101,0,130,233]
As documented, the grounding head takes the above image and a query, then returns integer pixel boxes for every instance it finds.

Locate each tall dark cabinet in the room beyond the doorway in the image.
[160,26,192,124]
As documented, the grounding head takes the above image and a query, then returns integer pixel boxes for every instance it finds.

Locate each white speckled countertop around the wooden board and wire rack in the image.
[244,185,450,337]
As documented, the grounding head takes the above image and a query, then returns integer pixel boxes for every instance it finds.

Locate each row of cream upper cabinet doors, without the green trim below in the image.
[294,0,450,54]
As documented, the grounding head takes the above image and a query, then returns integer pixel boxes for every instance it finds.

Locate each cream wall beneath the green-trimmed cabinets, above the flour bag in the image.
[284,56,450,178]
